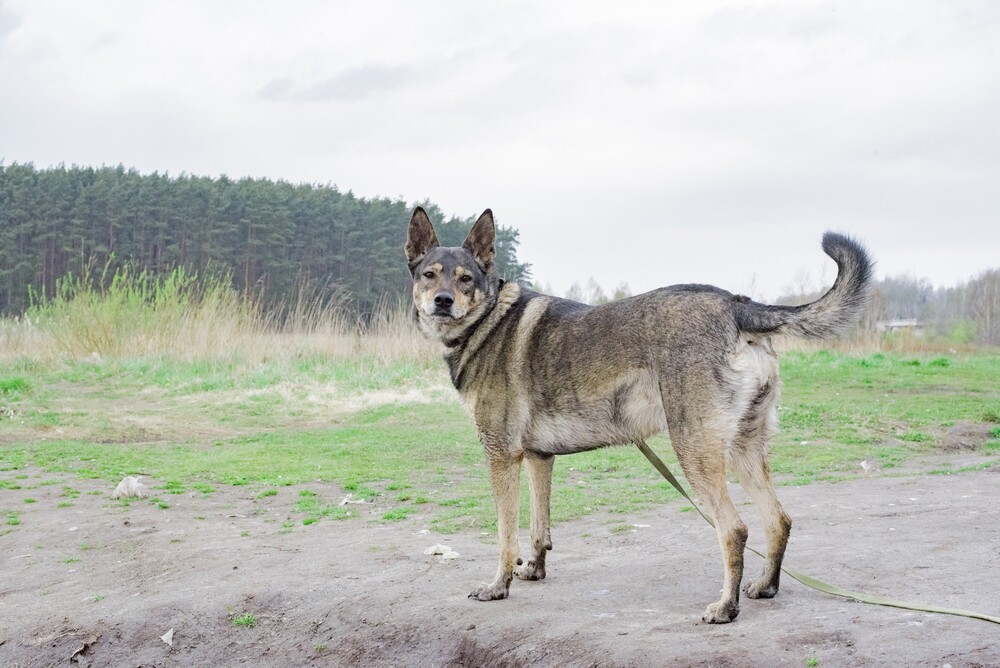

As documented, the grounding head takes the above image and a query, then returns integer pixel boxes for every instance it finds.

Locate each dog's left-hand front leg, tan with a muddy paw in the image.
[469,447,521,601]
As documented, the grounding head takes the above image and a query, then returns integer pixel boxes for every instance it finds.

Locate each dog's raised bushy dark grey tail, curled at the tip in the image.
[736,232,875,339]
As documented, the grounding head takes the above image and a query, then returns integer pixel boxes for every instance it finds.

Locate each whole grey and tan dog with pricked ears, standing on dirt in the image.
[405,207,873,623]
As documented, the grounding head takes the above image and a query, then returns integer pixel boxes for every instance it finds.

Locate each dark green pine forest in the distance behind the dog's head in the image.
[0,163,531,316]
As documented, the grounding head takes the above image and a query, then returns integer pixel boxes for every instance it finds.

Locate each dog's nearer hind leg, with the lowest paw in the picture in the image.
[670,430,747,624]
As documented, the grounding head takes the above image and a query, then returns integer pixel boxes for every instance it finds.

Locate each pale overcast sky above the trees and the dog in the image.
[0,0,1000,299]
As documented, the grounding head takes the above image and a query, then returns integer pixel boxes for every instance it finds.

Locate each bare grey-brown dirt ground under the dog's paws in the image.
[0,460,1000,668]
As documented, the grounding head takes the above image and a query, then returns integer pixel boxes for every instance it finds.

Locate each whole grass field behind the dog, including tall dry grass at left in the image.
[0,268,1000,532]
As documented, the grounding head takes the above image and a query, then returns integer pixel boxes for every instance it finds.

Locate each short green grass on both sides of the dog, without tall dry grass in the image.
[0,352,1000,533]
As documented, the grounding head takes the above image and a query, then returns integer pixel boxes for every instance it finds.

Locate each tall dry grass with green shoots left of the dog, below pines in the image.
[0,269,436,363]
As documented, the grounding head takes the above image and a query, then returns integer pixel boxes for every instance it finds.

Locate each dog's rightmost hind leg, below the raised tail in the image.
[732,382,792,598]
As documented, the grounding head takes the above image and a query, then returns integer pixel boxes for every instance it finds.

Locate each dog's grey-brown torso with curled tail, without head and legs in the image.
[446,234,871,454]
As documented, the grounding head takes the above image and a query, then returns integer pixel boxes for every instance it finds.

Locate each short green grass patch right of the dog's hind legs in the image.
[774,352,1000,475]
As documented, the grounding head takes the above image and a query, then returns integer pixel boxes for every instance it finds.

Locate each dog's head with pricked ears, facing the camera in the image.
[406,206,500,345]
